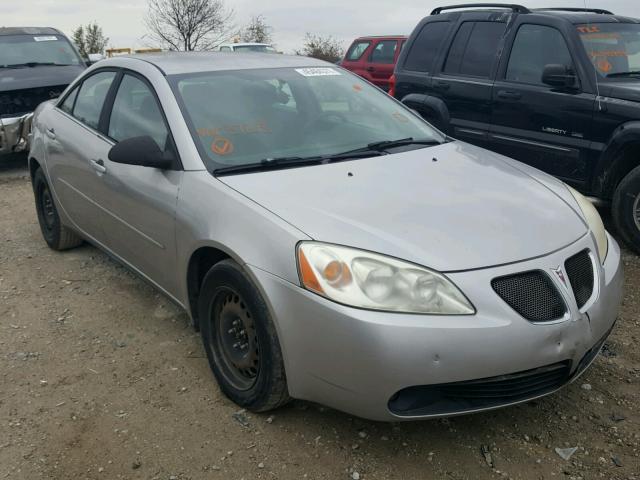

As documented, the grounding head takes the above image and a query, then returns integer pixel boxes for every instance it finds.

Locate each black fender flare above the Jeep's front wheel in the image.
[593,121,640,198]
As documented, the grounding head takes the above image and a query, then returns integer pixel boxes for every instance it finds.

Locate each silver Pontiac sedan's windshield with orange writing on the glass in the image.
[169,67,445,170]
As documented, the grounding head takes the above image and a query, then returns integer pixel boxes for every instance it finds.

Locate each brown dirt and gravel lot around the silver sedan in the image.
[0,161,640,480]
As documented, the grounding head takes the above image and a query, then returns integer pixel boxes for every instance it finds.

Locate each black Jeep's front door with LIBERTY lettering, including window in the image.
[490,24,595,185]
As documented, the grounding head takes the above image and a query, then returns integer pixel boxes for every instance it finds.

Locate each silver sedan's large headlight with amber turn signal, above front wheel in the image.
[298,242,475,315]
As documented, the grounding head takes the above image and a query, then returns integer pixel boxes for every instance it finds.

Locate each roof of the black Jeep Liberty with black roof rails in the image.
[426,4,640,24]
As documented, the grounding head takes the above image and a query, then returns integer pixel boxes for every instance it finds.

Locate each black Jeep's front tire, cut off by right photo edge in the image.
[611,167,640,253]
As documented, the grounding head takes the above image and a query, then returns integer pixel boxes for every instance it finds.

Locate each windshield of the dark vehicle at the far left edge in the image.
[0,35,82,67]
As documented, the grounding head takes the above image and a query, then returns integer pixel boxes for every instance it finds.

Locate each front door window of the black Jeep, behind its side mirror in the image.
[506,25,573,85]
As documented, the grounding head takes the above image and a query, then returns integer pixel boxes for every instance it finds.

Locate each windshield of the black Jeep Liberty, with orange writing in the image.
[576,23,640,78]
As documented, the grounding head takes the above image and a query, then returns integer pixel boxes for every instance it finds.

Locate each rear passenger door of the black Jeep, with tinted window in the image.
[431,16,508,146]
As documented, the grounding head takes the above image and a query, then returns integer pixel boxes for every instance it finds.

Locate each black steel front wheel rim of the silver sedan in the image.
[211,287,260,390]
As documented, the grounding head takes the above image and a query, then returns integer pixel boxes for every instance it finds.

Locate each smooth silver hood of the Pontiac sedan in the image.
[219,142,587,272]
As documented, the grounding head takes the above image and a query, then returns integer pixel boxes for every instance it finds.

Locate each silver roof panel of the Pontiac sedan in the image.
[100,52,335,75]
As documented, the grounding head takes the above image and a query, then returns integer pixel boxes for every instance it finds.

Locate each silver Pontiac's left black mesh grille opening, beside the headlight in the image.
[491,270,567,322]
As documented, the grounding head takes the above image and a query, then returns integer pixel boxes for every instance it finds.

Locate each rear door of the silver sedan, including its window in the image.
[46,70,117,244]
